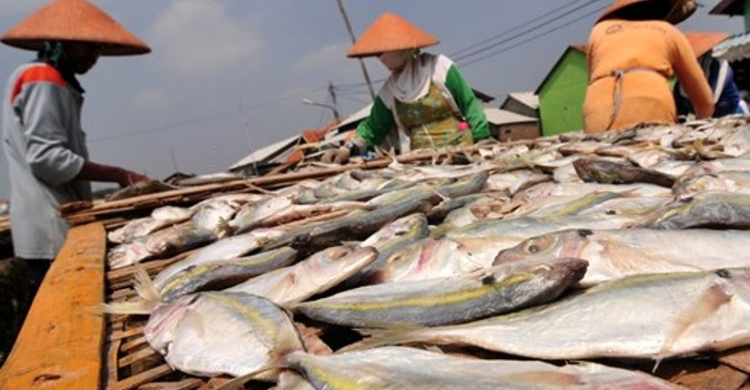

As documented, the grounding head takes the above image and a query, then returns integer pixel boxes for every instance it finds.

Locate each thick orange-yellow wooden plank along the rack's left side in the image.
[0,223,106,389]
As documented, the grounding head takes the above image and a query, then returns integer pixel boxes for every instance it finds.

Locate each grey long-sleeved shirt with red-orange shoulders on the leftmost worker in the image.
[0,63,91,259]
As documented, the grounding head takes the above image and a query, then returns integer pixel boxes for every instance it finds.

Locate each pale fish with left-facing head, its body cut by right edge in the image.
[493,229,750,286]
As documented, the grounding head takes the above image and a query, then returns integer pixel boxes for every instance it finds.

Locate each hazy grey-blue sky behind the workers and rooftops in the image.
[0,0,743,198]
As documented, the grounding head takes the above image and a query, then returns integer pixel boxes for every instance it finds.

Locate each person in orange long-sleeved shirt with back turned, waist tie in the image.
[583,0,714,133]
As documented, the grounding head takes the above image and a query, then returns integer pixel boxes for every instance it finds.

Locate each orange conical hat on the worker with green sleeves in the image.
[348,13,440,57]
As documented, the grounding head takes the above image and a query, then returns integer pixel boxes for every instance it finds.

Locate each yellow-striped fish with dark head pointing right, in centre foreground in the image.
[295,258,587,328]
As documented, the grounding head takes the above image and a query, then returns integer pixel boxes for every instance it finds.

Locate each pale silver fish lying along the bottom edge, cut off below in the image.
[285,347,683,390]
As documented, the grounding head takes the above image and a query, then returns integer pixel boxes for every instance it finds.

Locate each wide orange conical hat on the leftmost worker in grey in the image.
[0,0,151,55]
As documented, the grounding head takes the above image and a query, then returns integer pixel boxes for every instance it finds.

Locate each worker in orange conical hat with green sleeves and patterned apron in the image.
[323,13,489,162]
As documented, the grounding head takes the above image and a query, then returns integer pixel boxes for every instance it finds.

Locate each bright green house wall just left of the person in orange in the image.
[539,48,588,135]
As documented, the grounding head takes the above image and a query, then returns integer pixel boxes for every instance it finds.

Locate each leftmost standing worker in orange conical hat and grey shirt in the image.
[0,0,150,286]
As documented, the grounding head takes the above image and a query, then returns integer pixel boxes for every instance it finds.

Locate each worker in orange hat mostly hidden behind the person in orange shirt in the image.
[673,31,748,118]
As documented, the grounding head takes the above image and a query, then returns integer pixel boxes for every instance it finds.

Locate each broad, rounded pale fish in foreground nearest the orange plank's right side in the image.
[144,292,304,376]
